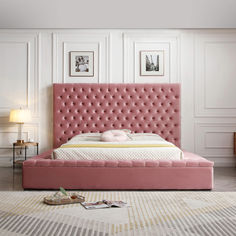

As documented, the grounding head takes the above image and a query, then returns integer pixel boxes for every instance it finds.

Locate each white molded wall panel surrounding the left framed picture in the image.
[53,31,111,83]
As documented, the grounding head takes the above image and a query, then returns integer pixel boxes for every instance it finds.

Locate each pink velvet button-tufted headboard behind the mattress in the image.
[53,84,180,148]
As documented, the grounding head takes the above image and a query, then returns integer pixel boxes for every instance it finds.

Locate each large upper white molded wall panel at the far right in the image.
[194,32,236,117]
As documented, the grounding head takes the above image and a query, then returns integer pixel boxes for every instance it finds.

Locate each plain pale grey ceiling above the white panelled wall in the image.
[0,0,236,29]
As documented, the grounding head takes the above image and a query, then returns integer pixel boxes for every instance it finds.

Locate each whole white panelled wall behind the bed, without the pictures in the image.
[0,29,236,166]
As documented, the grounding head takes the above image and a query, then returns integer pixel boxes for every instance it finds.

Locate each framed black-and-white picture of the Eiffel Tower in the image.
[140,50,164,76]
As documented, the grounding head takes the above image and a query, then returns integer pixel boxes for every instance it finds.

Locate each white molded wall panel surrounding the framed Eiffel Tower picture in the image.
[123,31,180,83]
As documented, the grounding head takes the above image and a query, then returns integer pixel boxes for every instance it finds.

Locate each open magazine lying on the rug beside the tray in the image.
[81,200,128,210]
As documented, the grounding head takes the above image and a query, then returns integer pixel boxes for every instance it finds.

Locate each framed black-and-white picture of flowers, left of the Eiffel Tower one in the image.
[70,51,94,77]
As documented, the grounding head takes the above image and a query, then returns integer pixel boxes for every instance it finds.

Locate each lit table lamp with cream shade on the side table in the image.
[9,108,31,143]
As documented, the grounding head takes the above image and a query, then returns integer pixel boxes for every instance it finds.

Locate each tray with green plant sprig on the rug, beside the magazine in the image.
[43,187,85,205]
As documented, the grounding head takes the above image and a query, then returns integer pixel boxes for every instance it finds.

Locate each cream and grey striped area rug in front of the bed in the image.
[0,191,236,236]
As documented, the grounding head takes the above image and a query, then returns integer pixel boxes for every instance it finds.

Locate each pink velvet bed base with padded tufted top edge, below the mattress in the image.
[23,152,213,189]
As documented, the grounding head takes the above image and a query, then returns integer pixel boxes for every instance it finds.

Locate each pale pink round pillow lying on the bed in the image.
[101,130,129,142]
